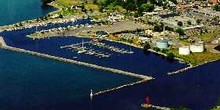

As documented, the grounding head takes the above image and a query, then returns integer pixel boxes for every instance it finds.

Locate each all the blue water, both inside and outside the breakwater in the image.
[0,0,220,110]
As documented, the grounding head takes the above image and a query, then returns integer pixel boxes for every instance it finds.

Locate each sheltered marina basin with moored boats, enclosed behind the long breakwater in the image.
[0,19,187,77]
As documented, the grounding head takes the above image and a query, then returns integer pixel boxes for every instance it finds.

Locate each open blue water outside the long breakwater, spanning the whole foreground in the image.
[0,50,220,110]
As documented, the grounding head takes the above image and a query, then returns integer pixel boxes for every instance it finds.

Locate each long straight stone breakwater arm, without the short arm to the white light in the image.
[3,46,153,80]
